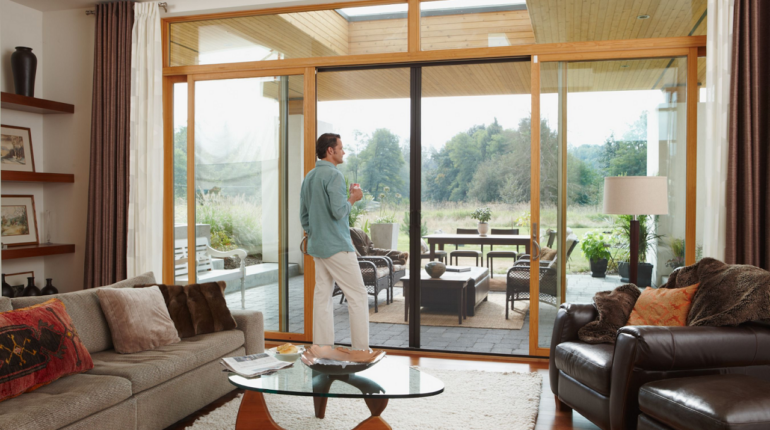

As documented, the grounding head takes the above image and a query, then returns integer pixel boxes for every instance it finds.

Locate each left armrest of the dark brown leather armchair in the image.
[548,303,599,395]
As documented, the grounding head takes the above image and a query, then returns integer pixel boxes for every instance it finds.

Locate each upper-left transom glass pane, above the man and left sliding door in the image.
[169,3,408,66]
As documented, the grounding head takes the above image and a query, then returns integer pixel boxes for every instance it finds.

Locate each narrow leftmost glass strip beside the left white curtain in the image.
[174,82,188,284]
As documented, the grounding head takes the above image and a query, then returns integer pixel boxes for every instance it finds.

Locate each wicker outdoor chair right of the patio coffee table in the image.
[505,240,578,319]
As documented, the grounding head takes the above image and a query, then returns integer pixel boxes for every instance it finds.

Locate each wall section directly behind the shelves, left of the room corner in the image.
[0,0,45,287]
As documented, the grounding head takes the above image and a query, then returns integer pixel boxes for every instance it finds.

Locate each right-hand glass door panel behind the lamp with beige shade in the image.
[538,58,687,347]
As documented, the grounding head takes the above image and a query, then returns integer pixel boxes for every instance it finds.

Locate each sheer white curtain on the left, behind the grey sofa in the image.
[127,2,163,282]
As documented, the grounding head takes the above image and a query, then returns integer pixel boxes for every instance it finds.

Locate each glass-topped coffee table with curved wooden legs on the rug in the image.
[230,356,444,430]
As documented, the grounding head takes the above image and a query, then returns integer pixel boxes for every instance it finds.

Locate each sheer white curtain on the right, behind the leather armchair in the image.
[698,0,735,260]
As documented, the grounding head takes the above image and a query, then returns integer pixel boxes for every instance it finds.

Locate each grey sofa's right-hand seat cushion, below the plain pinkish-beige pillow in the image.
[89,330,244,394]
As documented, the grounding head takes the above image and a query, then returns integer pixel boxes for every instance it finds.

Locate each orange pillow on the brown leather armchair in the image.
[626,284,700,327]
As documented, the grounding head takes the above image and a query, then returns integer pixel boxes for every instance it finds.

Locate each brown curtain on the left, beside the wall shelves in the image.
[85,1,134,288]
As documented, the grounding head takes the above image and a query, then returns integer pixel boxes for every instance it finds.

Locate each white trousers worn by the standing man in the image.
[313,252,369,349]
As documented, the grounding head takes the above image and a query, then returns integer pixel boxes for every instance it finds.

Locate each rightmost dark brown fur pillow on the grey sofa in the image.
[185,281,237,335]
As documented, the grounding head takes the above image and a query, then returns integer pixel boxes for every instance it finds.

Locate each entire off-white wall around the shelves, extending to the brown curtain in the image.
[0,0,95,292]
